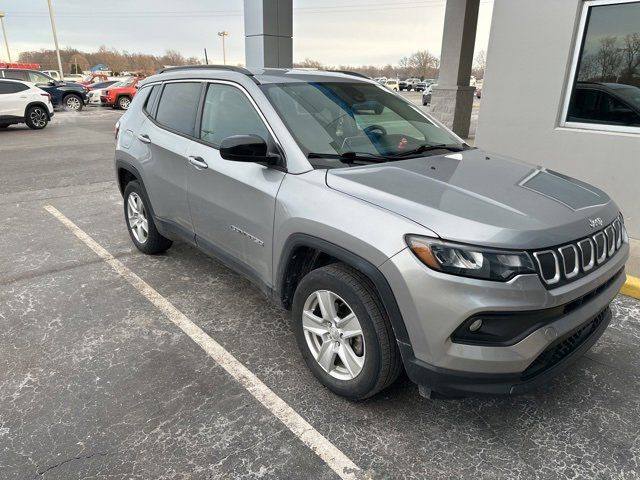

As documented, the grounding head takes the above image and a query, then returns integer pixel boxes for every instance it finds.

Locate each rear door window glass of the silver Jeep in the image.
[156,82,201,136]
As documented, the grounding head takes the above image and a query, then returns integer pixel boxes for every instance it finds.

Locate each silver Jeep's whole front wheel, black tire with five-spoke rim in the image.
[291,263,402,400]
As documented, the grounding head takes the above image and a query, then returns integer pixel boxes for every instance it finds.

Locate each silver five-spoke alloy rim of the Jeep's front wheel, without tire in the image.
[302,290,366,380]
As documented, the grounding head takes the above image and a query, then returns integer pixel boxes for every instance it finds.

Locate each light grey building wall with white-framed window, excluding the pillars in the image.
[478,0,640,276]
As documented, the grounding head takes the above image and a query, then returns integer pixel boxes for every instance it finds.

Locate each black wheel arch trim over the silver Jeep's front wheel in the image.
[274,233,413,348]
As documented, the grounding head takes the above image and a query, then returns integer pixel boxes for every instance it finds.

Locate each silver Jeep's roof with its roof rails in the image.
[145,65,374,85]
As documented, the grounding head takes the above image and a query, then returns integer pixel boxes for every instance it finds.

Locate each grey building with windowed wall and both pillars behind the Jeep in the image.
[244,0,640,276]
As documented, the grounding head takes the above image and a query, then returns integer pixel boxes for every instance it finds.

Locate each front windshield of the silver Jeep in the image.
[261,82,465,164]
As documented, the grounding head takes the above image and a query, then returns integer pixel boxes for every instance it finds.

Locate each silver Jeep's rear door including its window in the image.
[136,81,202,236]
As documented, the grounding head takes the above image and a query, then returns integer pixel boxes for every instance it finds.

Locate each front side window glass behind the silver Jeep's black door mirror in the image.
[200,83,269,146]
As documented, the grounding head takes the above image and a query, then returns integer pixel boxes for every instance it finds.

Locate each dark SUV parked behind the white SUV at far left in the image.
[0,68,88,112]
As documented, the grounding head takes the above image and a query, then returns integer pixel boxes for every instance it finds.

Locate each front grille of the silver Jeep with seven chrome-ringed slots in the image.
[533,216,626,287]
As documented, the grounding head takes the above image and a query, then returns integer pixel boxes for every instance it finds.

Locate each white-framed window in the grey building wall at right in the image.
[562,0,640,133]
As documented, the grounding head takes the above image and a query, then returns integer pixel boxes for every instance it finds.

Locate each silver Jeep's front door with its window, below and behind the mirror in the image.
[187,83,285,286]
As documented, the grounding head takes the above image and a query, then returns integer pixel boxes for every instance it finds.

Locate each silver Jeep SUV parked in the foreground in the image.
[115,66,629,399]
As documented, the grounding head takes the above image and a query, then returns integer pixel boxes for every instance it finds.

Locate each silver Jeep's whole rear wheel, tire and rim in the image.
[124,180,173,255]
